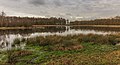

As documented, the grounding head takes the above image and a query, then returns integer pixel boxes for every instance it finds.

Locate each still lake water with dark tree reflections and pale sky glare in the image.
[0,26,120,51]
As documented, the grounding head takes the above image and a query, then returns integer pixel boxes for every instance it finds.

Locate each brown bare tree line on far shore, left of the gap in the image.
[0,16,66,27]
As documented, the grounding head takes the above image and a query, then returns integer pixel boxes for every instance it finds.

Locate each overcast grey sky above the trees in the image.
[0,0,120,19]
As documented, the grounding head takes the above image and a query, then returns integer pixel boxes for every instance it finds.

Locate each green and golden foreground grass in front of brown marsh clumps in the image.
[0,43,120,65]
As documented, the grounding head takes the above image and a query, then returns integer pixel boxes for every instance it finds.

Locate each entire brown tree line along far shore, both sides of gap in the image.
[0,13,120,27]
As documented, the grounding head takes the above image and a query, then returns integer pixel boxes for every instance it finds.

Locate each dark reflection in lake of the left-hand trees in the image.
[0,26,66,35]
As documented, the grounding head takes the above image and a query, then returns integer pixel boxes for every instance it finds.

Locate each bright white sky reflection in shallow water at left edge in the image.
[0,34,25,51]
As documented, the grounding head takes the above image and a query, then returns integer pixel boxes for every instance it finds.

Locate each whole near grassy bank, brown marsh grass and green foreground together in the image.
[0,34,120,65]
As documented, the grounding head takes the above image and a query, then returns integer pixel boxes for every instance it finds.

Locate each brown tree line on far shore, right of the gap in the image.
[70,16,120,25]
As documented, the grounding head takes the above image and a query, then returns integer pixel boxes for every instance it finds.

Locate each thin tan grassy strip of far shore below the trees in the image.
[0,25,120,30]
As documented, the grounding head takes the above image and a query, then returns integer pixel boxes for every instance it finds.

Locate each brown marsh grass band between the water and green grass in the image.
[27,34,120,47]
